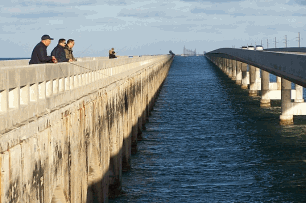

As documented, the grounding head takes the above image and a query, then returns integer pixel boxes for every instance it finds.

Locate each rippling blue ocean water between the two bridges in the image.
[109,56,306,203]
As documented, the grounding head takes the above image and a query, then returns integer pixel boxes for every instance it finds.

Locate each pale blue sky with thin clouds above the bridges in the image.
[0,0,306,58]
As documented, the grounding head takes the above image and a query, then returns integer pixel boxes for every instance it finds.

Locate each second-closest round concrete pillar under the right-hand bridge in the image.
[260,70,271,107]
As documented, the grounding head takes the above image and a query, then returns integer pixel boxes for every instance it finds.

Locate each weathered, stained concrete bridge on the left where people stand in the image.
[0,55,173,203]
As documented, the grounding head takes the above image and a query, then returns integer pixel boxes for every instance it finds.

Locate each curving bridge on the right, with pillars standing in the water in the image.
[205,48,306,124]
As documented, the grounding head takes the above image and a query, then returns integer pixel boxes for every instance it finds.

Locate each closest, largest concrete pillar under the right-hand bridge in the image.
[280,78,293,125]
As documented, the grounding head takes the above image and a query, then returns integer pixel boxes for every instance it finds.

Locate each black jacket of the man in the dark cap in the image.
[29,42,52,64]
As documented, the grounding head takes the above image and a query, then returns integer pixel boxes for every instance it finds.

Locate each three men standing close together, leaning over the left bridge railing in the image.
[29,35,76,64]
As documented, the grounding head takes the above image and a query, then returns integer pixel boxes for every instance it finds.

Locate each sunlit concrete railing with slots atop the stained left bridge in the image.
[0,55,167,134]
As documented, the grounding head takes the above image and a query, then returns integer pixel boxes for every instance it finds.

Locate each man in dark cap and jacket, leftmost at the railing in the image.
[29,35,57,64]
